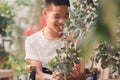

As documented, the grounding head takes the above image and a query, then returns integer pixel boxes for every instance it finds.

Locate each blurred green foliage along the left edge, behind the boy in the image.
[0,1,29,75]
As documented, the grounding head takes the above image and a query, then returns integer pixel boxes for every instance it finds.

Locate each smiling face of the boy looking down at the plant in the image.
[45,4,69,33]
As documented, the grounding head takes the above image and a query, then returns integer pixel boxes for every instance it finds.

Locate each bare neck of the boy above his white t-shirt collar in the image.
[43,27,62,40]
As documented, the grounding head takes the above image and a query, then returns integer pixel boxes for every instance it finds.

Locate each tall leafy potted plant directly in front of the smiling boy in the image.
[49,0,97,80]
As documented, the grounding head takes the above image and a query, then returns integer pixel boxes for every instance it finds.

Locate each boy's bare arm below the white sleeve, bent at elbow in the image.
[27,59,54,80]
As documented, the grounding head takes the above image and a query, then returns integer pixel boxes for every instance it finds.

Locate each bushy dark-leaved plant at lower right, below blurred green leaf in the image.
[94,18,120,78]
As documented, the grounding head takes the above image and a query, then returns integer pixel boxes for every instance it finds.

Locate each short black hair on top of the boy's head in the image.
[44,0,70,8]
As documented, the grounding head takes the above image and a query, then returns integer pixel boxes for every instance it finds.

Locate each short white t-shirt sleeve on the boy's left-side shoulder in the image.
[25,37,40,61]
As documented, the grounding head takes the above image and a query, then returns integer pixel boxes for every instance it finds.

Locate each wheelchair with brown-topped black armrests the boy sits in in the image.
[25,65,99,80]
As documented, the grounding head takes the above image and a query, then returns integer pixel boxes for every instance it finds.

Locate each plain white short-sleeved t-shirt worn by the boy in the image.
[25,30,63,66]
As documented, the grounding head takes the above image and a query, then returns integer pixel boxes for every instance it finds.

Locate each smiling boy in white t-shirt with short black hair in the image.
[25,0,84,80]
